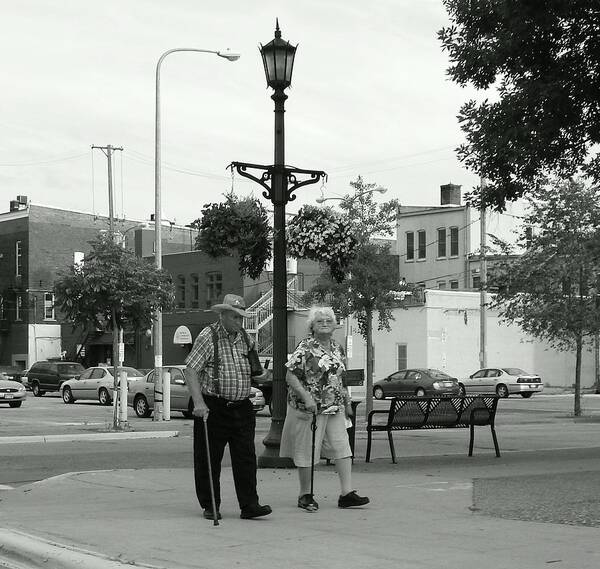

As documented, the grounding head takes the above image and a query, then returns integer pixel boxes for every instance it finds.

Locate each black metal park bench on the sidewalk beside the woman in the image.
[365,395,500,464]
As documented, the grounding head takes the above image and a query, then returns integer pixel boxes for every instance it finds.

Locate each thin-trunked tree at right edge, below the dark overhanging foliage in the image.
[490,180,600,416]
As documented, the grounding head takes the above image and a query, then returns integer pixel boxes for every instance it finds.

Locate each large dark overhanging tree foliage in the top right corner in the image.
[438,0,600,211]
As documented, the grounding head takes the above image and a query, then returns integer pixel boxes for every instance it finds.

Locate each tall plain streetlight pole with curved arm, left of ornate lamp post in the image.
[153,47,240,421]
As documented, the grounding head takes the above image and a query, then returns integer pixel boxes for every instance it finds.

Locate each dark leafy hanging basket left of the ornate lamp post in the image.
[193,193,272,279]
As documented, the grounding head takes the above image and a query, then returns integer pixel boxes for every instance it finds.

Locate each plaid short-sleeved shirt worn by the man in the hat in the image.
[185,322,250,401]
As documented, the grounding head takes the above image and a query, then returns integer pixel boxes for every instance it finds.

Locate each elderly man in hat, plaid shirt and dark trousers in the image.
[185,294,271,520]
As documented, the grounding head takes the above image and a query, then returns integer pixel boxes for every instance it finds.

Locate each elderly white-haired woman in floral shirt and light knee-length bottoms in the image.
[280,306,369,511]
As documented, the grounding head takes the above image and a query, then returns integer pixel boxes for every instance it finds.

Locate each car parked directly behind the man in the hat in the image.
[127,365,266,418]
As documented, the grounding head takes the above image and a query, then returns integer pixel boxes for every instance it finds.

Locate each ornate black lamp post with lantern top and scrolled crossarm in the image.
[230,21,326,468]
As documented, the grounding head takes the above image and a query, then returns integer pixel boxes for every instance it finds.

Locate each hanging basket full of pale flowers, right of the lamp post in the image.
[286,205,357,282]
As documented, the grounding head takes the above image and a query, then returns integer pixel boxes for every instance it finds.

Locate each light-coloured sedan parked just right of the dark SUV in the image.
[61,366,144,405]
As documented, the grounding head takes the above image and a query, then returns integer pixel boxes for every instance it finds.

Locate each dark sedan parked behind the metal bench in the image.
[373,369,461,399]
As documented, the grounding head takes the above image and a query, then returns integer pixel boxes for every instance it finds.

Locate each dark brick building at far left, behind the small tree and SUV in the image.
[0,196,195,368]
